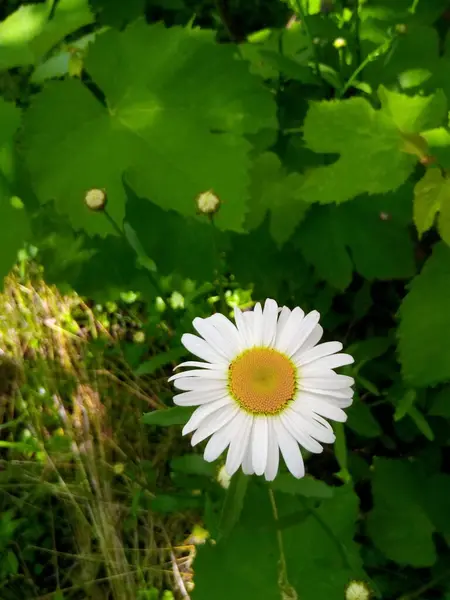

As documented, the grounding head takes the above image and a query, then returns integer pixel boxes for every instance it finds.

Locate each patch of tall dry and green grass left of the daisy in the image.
[0,273,192,600]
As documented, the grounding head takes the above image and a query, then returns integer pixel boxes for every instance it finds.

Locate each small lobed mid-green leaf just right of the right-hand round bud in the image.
[246,152,308,246]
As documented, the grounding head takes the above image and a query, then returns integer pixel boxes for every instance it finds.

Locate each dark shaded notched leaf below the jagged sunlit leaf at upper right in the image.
[295,197,415,290]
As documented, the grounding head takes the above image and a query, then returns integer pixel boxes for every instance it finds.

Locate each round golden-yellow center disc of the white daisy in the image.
[228,348,297,415]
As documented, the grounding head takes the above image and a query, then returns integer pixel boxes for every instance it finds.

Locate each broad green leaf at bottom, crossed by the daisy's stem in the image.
[193,486,364,600]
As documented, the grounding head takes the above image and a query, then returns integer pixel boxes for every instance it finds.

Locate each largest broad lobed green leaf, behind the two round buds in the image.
[24,21,276,234]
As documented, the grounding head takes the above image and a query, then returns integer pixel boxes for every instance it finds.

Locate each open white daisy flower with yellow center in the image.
[169,299,354,481]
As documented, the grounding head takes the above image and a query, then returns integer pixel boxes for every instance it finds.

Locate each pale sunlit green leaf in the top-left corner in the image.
[0,0,94,71]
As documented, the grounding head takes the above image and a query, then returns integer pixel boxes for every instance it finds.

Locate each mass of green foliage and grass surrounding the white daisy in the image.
[0,0,450,600]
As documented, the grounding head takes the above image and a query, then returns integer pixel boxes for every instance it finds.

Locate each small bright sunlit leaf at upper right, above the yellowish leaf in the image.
[378,86,447,133]
